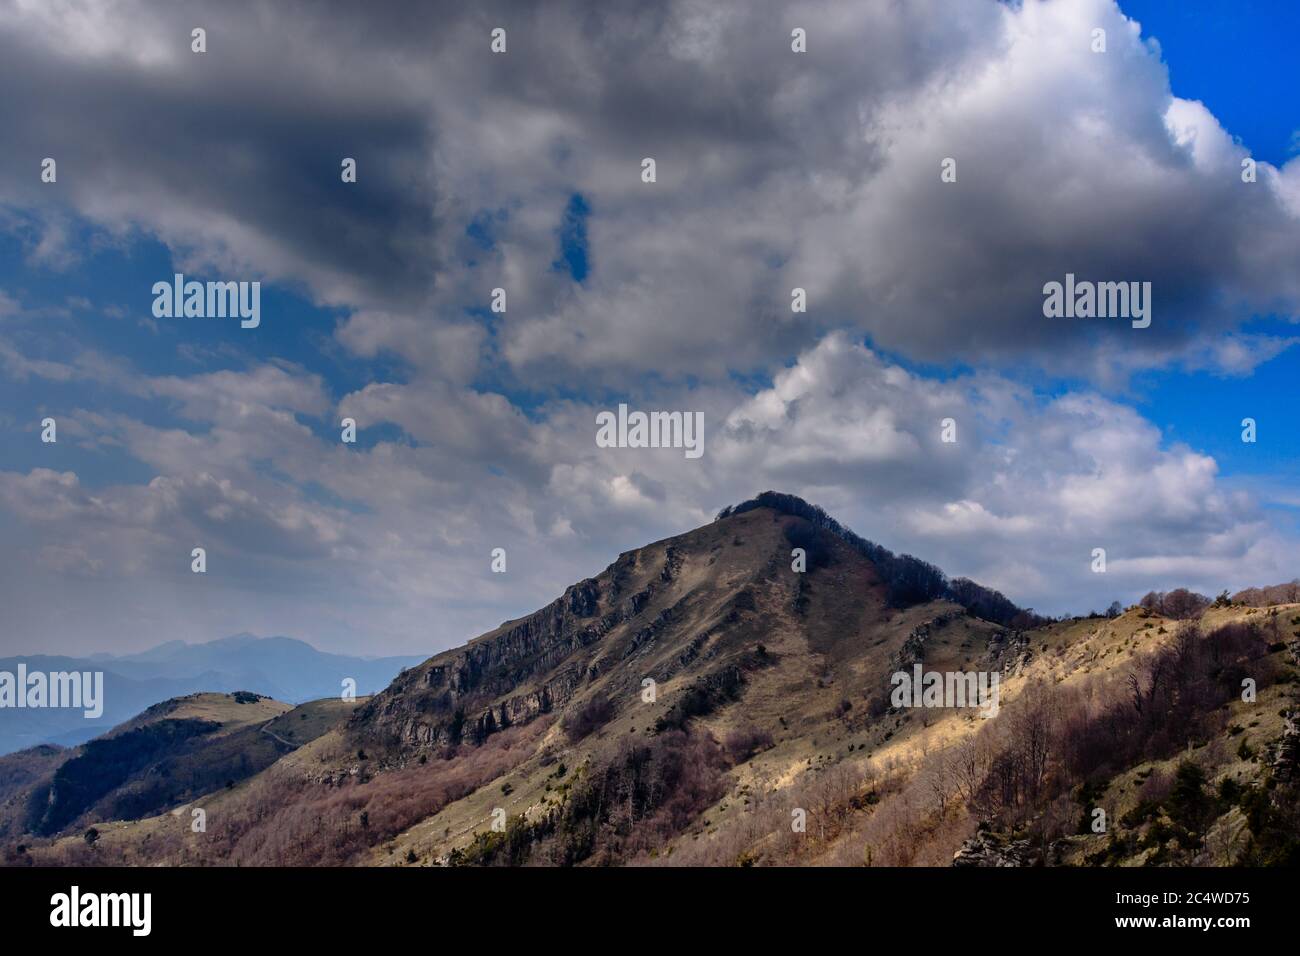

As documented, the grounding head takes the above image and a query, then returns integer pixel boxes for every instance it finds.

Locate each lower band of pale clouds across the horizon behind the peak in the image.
[0,325,1294,650]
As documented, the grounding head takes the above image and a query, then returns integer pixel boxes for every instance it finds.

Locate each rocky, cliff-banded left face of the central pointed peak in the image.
[351,511,800,749]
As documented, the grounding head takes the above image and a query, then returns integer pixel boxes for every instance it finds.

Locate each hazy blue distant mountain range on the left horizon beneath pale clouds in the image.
[0,633,424,753]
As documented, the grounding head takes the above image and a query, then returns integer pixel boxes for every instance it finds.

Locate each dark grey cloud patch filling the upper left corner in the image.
[0,4,436,303]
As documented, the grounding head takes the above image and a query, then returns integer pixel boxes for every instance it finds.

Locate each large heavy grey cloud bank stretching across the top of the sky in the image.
[0,0,1300,384]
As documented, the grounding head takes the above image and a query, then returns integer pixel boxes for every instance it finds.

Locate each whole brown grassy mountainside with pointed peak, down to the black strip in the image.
[5,496,1300,865]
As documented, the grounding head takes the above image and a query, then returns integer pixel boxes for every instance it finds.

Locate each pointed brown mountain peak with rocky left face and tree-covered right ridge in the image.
[354,492,1021,749]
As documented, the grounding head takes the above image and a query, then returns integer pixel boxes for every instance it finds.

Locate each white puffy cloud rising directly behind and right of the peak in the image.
[538,333,1294,613]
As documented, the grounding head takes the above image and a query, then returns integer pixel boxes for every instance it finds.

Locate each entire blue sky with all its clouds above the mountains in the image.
[0,0,1300,653]
